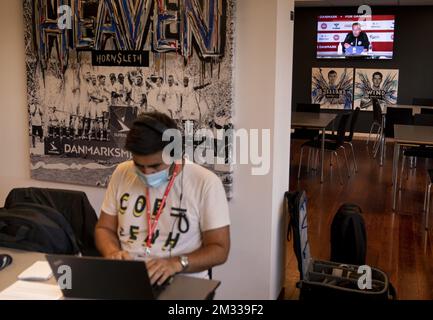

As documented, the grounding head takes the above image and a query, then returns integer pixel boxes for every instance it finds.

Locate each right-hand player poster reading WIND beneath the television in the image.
[354,69,399,111]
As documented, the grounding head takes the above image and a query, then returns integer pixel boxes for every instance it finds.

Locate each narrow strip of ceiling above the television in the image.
[295,0,433,7]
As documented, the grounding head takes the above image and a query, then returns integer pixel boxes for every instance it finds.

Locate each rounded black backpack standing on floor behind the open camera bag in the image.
[331,203,367,265]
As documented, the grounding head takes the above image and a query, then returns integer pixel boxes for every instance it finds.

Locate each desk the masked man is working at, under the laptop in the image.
[0,248,221,300]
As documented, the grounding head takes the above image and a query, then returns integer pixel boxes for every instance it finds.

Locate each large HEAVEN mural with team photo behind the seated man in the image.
[24,0,235,198]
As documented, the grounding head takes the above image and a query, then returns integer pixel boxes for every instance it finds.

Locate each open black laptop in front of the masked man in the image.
[46,255,168,300]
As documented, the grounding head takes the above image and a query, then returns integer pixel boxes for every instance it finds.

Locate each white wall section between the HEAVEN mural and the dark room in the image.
[216,0,294,299]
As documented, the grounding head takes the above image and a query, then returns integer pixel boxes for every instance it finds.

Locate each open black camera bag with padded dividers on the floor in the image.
[300,261,397,301]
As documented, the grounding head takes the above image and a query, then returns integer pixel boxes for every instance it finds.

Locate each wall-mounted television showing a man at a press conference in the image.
[317,15,395,59]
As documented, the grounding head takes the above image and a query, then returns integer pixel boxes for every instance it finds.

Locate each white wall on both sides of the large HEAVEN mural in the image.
[0,0,294,299]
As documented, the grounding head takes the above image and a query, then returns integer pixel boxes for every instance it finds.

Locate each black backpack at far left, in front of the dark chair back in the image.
[0,203,80,255]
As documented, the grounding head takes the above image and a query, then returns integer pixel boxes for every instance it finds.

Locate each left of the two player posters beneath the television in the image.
[311,68,353,110]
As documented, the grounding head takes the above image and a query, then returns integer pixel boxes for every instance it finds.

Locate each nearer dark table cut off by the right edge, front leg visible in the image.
[392,124,433,211]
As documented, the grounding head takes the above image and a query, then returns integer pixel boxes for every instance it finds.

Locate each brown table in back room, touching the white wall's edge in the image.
[292,112,337,183]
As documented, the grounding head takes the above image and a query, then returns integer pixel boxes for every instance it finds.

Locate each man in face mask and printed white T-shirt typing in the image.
[95,112,230,285]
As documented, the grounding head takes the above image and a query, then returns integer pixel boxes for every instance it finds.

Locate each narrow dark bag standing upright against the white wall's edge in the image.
[284,191,311,280]
